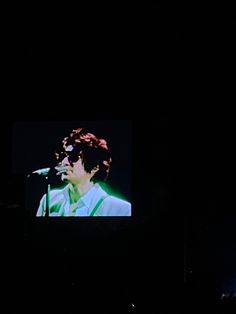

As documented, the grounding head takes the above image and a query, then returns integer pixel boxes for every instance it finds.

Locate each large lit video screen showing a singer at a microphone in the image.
[12,120,132,217]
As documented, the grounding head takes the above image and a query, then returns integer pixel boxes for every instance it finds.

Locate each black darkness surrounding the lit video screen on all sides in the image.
[0,6,236,313]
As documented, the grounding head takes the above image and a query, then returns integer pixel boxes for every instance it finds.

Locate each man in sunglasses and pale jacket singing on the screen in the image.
[37,128,131,216]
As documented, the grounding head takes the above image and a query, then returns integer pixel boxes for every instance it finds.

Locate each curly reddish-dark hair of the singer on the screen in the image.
[56,128,112,182]
